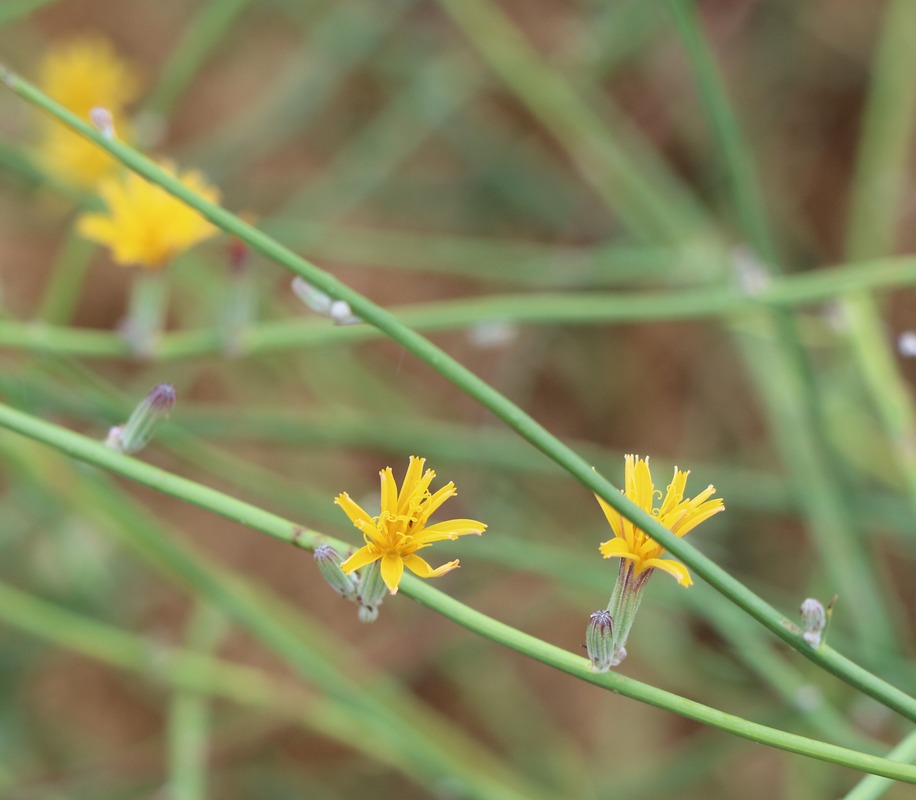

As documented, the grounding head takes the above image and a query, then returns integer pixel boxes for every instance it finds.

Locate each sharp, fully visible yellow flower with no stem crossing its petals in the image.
[334,456,487,594]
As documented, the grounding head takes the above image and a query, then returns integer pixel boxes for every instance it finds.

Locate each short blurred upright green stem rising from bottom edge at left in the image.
[168,603,226,800]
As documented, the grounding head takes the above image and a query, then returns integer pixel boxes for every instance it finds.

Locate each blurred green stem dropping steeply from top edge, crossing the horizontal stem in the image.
[668,0,896,652]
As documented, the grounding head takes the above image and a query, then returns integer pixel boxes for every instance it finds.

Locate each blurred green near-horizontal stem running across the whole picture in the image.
[0,250,916,361]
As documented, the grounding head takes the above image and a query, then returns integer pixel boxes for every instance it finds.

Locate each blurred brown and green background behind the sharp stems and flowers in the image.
[0,0,916,800]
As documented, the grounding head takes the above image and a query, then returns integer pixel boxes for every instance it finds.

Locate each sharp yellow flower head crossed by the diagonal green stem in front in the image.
[596,455,725,586]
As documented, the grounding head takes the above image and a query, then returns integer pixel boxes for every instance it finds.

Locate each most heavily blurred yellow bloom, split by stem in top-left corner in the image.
[38,36,139,188]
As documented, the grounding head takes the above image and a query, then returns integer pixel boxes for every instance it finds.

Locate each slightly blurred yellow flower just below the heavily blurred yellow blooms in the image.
[77,163,219,269]
